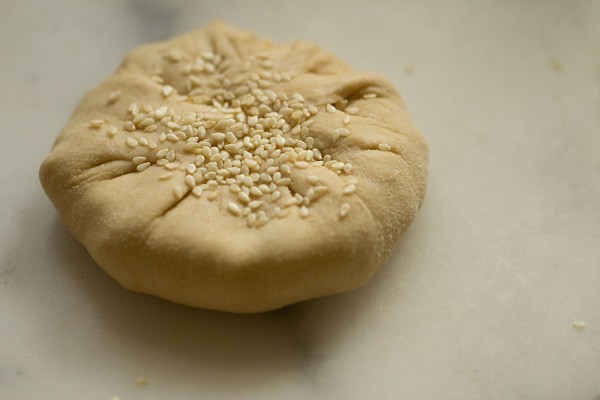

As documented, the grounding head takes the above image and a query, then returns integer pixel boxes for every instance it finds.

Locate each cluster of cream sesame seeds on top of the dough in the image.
[89,51,391,228]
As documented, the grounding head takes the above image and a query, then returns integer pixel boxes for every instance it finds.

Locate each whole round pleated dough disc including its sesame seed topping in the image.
[40,23,427,313]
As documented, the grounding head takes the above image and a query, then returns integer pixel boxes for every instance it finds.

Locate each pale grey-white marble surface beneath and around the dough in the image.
[0,0,600,400]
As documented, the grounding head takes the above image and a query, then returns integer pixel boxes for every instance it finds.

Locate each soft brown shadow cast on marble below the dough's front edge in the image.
[42,212,372,392]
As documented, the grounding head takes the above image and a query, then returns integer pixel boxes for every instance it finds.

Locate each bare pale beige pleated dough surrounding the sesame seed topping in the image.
[40,23,427,313]
